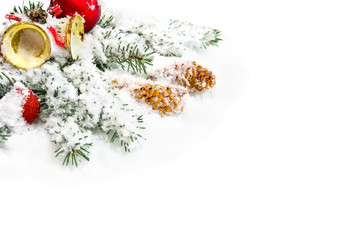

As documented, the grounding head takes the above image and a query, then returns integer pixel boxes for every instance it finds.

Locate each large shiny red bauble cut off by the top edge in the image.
[50,0,101,32]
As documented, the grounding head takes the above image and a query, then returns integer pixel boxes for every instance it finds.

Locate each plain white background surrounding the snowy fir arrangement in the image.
[0,0,360,240]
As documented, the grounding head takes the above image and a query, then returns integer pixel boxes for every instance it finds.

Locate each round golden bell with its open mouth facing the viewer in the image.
[1,22,51,69]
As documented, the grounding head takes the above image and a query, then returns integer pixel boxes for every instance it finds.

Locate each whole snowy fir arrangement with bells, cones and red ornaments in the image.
[0,0,221,166]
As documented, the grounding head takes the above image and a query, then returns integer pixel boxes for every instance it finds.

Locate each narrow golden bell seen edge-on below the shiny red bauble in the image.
[65,15,85,60]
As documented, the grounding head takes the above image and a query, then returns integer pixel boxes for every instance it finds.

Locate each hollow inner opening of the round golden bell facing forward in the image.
[11,28,46,59]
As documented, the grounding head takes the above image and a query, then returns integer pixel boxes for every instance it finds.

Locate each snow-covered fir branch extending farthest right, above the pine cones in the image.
[95,15,222,59]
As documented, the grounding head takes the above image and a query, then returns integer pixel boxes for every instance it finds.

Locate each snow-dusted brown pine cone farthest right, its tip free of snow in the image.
[148,62,216,93]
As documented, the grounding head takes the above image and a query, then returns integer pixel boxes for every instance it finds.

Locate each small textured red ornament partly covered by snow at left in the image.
[16,89,40,124]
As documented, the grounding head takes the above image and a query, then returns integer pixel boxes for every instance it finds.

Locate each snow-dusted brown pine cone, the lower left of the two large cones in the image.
[112,80,187,115]
